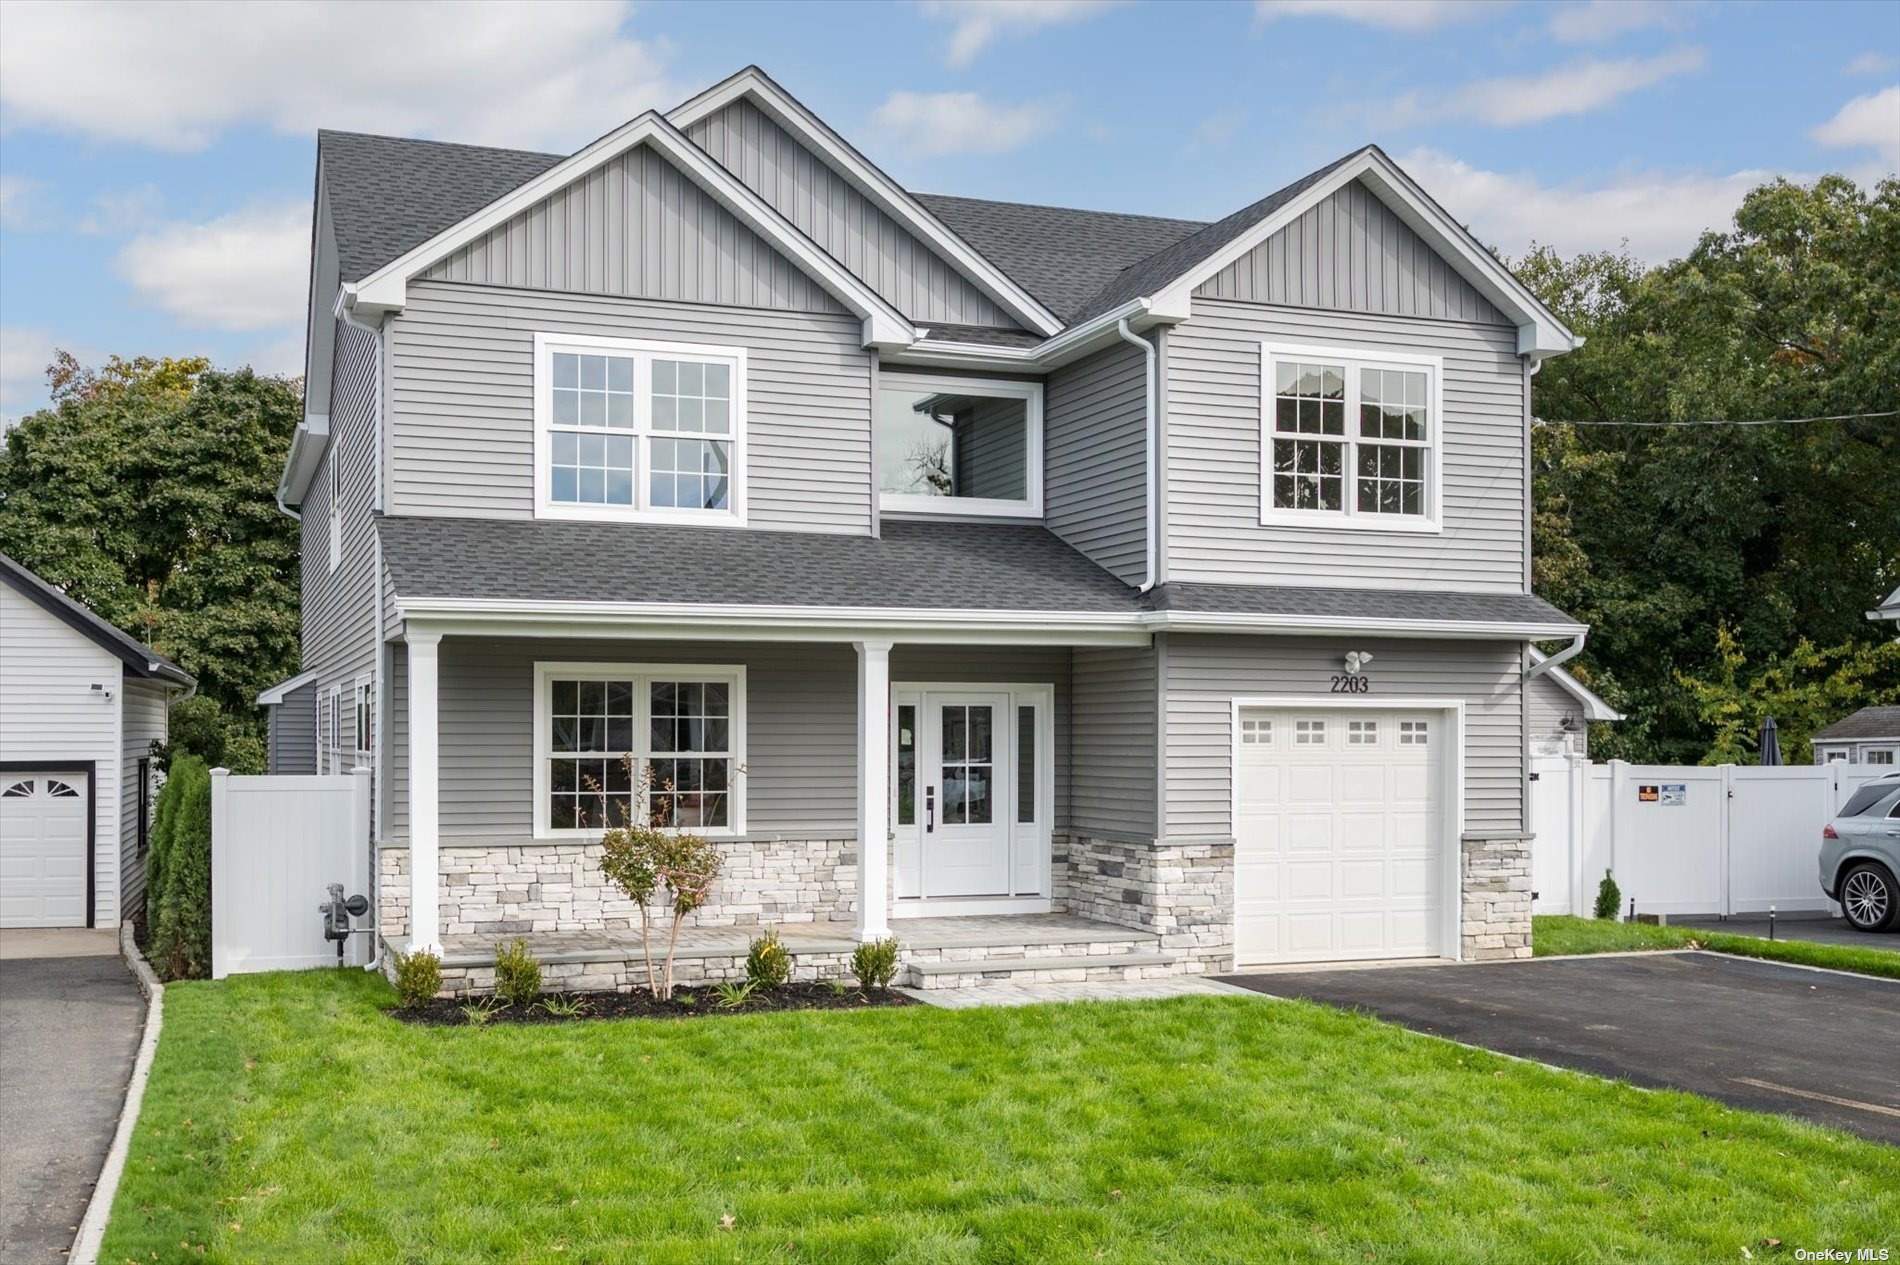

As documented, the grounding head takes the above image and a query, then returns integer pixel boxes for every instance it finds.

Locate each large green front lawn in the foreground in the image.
[101,971,1900,1265]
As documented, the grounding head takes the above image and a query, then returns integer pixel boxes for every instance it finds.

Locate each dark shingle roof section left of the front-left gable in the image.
[317,131,566,281]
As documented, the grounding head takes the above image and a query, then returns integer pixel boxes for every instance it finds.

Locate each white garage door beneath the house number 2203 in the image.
[1233,708,1450,967]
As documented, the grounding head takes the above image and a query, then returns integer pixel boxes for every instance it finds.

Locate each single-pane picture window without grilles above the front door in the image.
[874,372,1043,517]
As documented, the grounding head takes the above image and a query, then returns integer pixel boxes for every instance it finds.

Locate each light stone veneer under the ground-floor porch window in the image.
[376,840,857,938]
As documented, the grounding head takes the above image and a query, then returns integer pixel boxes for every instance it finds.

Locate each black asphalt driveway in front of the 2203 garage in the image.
[1226,953,1900,1145]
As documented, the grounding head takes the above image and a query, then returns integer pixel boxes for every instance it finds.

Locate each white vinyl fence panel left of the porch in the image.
[211,769,371,980]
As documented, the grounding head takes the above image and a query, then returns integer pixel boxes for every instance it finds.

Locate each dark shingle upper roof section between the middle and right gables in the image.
[914,194,1207,323]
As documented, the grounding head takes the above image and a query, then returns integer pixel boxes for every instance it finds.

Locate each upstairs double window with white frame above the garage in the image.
[1260,339,1442,532]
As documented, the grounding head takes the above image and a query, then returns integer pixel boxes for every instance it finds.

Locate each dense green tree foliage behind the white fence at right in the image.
[1518,177,1900,762]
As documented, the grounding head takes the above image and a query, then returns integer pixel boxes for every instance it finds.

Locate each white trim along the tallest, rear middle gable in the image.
[667,66,1062,334]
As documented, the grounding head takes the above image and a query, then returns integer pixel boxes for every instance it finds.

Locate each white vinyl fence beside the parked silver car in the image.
[1530,756,1891,914]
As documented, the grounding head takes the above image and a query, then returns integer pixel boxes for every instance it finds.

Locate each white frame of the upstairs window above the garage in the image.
[1260,342,1444,536]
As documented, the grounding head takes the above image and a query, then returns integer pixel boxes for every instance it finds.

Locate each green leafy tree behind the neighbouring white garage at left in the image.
[0,353,302,750]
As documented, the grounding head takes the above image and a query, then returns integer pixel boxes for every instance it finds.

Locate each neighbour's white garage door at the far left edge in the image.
[0,773,91,927]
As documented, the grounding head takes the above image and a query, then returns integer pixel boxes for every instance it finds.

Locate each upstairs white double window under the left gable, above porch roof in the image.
[534,334,745,524]
